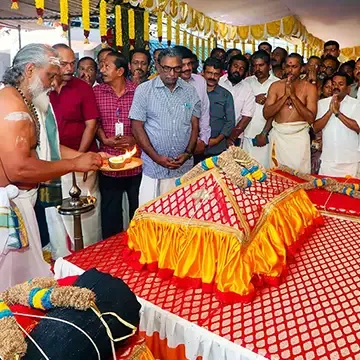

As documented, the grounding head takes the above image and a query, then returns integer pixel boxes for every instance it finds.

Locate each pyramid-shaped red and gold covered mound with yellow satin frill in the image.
[124,147,322,303]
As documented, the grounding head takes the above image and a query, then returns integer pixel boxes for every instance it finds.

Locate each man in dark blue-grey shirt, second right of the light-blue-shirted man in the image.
[199,58,235,160]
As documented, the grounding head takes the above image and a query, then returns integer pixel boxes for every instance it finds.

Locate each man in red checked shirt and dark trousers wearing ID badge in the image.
[94,51,141,239]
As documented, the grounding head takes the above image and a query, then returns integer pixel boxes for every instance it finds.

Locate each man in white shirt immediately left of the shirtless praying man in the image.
[243,50,279,168]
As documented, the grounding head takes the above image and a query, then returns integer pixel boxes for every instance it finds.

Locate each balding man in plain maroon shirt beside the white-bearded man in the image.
[50,44,102,245]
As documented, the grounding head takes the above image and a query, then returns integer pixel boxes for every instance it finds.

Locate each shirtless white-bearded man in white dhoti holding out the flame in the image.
[0,44,102,292]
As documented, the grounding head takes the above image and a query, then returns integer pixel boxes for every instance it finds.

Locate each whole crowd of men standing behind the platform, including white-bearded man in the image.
[0,41,360,291]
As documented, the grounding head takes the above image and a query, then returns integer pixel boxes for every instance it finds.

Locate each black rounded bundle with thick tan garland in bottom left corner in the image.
[0,269,154,360]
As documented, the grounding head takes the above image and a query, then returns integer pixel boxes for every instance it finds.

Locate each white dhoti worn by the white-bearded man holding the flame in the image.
[0,185,53,292]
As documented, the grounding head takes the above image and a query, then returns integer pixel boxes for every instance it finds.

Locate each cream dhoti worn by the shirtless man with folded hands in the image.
[269,121,311,174]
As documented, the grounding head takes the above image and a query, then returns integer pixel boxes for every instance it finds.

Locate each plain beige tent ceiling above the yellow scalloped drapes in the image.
[186,0,360,47]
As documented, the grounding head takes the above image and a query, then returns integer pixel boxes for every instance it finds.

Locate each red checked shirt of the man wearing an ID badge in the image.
[94,80,142,177]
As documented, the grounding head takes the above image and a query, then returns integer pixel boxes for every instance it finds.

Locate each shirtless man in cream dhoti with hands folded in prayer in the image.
[264,53,318,173]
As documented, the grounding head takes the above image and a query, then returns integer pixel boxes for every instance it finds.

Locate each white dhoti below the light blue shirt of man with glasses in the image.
[139,174,177,206]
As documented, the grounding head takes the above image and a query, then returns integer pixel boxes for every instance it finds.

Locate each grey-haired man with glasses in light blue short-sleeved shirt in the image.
[129,48,201,206]
